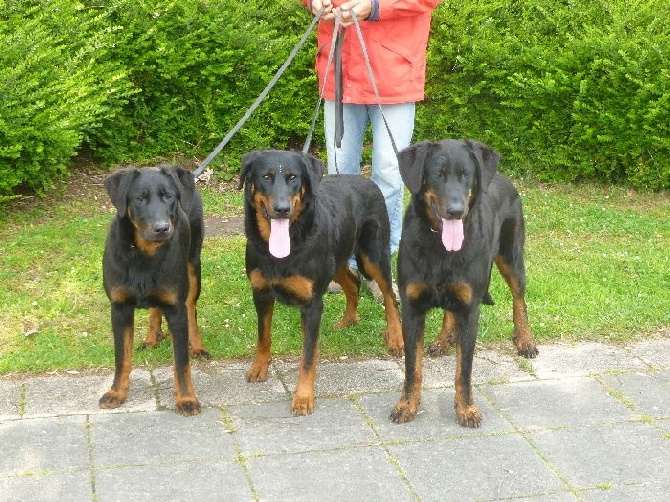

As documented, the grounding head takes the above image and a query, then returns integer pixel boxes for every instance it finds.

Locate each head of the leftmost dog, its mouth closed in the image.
[105,165,195,247]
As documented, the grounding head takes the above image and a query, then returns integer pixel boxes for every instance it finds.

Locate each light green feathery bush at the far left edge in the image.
[0,0,132,202]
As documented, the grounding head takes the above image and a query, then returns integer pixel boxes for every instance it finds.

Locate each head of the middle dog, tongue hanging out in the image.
[238,150,323,258]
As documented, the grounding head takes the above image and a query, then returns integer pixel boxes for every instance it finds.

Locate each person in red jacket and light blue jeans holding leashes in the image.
[302,0,440,296]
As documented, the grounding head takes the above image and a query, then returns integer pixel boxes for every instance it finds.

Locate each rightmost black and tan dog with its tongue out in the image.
[391,140,538,427]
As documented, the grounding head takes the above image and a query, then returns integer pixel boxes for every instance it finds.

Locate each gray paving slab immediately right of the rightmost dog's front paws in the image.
[484,377,638,429]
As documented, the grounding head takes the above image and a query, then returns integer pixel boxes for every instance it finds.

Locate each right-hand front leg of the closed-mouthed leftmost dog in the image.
[163,304,200,416]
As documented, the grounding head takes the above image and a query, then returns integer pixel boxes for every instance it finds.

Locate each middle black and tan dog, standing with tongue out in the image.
[239,150,403,415]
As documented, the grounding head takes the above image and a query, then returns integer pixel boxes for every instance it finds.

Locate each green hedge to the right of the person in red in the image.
[426,0,670,189]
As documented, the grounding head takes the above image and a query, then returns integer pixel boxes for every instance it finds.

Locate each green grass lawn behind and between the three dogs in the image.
[0,175,670,374]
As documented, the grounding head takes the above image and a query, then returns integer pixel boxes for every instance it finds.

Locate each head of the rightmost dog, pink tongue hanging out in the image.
[398,139,499,251]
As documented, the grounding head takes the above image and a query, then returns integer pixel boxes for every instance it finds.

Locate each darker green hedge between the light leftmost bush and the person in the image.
[93,0,316,171]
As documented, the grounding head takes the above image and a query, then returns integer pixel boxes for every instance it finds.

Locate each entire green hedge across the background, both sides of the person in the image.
[0,0,670,201]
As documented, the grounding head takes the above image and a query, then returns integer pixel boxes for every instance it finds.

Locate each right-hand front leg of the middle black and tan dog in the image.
[291,297,323,415]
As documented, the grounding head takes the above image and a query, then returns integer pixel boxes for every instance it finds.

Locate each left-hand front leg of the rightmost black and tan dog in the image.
[391,301,426,424]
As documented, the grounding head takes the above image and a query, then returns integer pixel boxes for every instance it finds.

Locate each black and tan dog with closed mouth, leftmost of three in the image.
[100,166,209,415]
